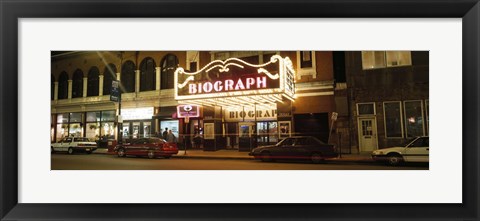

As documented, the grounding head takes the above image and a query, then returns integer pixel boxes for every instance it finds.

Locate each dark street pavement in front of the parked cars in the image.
[51,151,428,170]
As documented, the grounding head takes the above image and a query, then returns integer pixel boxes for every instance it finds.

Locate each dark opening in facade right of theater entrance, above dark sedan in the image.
[293,113,329,143]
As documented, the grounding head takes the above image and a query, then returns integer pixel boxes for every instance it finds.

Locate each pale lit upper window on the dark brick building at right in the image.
[362,51,412,70]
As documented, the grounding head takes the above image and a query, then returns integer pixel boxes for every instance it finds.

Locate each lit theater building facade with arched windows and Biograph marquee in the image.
[51,51,336,151]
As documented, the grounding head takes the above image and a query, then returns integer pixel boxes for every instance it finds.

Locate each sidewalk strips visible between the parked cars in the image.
[93,149,373,163]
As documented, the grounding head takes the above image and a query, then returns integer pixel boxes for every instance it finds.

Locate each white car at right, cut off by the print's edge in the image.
[372,137,430,166]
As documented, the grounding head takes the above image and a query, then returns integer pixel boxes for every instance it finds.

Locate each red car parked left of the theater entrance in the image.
[114,137,178,159]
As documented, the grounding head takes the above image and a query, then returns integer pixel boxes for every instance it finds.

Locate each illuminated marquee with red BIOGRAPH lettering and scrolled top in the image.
[174,55,295,100]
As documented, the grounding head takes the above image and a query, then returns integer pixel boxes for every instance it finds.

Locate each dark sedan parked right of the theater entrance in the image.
[249,136,338,163]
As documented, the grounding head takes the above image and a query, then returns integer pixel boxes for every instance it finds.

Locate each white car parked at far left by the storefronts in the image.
[50,137,97,154]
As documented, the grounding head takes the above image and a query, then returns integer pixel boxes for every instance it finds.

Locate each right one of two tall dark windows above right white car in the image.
[404,101,424,137]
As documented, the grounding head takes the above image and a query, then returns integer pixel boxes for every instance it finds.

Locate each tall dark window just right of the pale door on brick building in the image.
[383,101,403,137]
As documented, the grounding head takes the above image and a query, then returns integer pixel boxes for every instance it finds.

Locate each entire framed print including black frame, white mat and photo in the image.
[0,0,480,220]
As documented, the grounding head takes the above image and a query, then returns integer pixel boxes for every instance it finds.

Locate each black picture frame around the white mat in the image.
[0,0,480,221]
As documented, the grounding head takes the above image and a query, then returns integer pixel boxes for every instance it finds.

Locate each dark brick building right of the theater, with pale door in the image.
[335,51,429,153]
